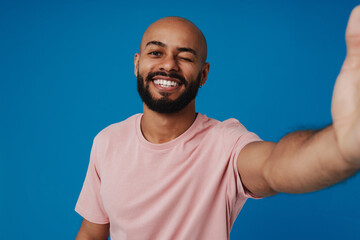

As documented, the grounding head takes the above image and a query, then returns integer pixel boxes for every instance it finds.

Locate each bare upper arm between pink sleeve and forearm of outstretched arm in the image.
[237,141,276,197]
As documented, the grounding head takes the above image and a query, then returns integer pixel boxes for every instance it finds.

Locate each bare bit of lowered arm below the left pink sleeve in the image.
[75,218,110,240]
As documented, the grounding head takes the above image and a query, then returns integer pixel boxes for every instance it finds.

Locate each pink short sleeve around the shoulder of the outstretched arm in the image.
[223,119,262,227]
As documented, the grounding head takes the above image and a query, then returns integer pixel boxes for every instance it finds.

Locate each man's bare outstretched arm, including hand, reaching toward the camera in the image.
[237,6,360,196]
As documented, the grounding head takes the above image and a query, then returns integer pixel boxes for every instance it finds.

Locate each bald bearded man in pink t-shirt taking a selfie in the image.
[76,7,360,239]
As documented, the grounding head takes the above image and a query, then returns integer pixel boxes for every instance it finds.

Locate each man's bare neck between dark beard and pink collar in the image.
[141,100,196,144]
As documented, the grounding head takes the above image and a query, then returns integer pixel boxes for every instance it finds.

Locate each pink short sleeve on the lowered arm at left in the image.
[75,138,109,224]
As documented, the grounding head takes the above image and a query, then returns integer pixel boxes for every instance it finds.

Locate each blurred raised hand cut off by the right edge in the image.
[331,5,360,168]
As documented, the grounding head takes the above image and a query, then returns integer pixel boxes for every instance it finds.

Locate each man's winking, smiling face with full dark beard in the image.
[135,17,209,113]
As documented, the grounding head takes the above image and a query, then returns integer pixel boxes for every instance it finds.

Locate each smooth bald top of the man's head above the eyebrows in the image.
[139,17,207,63]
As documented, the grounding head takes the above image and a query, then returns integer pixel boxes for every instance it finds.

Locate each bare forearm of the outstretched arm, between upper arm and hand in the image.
[264,126,360,193]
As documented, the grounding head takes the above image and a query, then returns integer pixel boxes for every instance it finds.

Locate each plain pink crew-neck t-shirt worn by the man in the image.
[75,113,260,240]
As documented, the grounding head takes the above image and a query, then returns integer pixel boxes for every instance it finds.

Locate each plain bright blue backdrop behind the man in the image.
[0,0,360,239]
